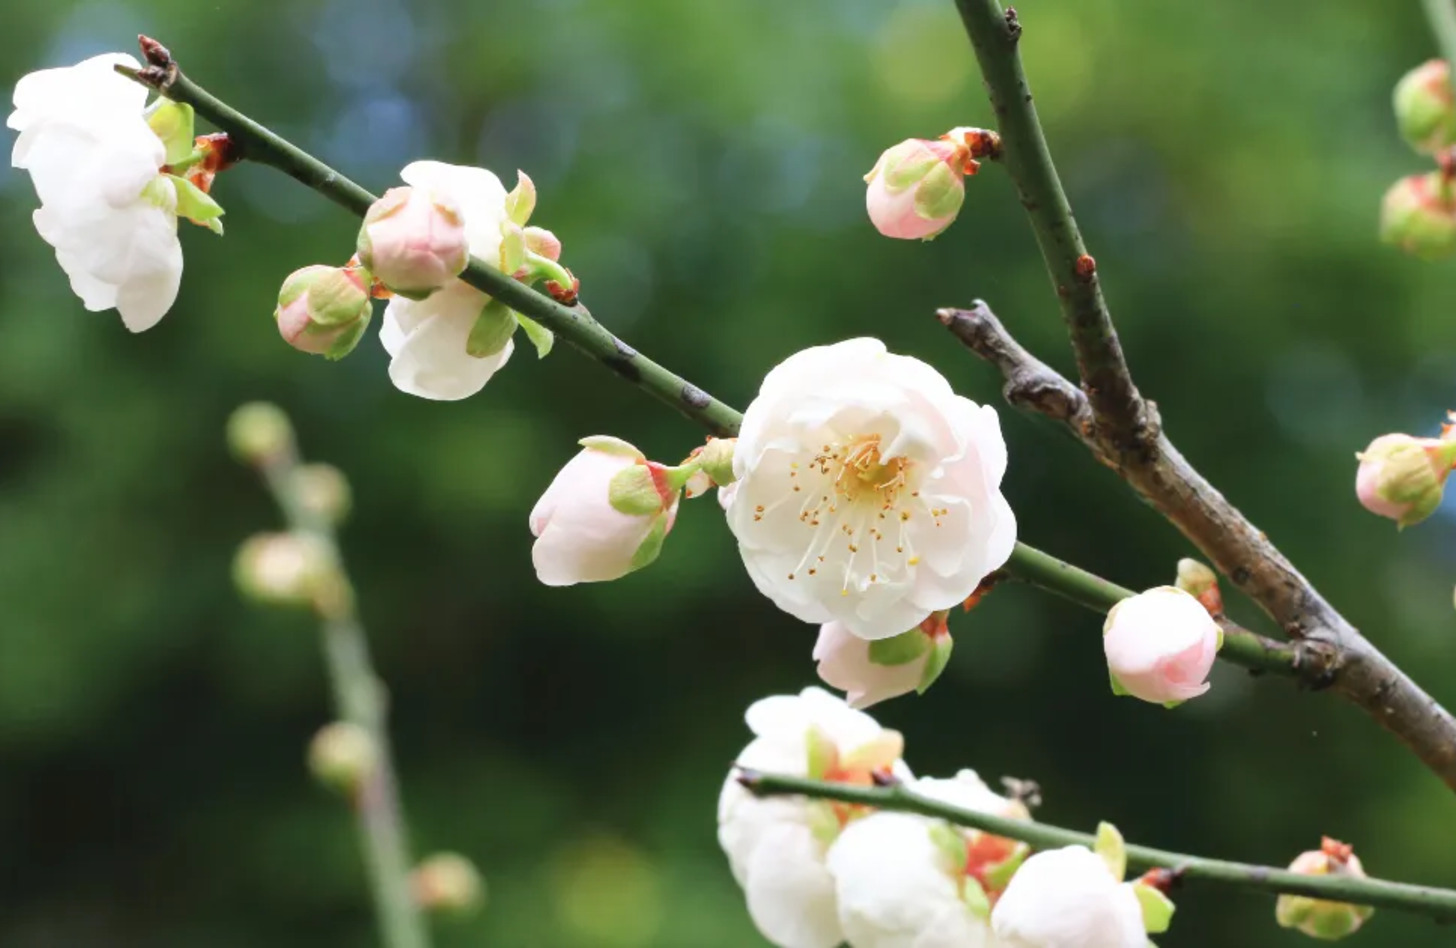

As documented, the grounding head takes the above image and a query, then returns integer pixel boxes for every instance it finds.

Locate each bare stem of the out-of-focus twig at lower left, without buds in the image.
[261,443,430,948]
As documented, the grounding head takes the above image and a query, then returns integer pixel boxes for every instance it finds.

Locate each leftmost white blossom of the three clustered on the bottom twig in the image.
[718,687,911,948]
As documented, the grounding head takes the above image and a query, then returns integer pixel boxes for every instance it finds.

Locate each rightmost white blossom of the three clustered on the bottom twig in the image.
[992,846,1147,948]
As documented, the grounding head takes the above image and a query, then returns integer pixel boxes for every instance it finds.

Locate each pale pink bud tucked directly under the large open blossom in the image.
[814,612,951,708]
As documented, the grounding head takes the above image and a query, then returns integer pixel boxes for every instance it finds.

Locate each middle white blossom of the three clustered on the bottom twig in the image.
[828,770,1028,948]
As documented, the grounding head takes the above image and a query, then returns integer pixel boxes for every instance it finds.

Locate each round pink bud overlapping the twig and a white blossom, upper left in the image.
[358,188,470,300]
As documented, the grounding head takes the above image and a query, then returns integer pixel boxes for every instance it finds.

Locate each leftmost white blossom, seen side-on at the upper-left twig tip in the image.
[6,52,182,332]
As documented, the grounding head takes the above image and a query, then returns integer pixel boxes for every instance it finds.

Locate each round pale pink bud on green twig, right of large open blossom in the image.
[1102,585,1223,705]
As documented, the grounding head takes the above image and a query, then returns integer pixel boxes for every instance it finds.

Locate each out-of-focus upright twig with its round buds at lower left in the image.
[227,402,430,948]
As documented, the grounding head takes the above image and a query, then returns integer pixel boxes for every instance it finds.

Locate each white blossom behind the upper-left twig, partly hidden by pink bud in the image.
[379,162,514,402]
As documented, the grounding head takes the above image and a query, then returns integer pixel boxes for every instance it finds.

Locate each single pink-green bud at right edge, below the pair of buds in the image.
[1356,434,1456,527]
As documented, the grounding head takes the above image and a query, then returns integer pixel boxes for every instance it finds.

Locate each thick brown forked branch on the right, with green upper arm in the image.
[942,0,1456,789]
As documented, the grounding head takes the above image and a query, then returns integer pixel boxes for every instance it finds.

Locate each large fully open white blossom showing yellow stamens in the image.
[728,339,1016,639]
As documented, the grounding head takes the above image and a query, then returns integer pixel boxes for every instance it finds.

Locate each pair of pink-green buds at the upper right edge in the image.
[1380,60,1456,259]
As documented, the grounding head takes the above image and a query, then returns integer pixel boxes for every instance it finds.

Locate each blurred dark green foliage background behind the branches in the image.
[0,0,1456,948]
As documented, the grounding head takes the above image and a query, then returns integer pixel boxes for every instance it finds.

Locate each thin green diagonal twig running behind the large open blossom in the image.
[119,46,1297,674]
